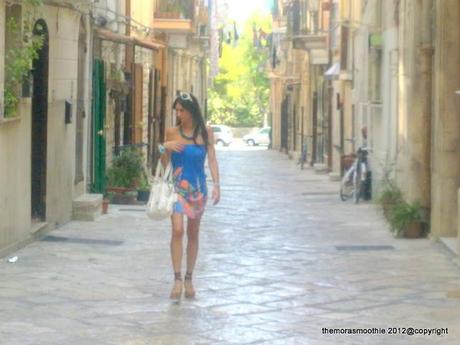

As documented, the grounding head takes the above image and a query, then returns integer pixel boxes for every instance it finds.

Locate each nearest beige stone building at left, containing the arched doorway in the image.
[0,1,91,252]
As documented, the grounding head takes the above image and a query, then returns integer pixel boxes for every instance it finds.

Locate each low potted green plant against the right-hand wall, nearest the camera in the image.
[390,201,423,238]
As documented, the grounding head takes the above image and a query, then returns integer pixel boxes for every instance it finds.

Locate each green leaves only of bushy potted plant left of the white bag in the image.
[107,148,143,188]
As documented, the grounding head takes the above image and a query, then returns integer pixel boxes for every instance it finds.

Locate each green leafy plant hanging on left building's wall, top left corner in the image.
[4,0,44,117]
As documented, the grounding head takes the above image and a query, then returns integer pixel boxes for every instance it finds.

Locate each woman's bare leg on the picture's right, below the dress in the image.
[184,216,201,298]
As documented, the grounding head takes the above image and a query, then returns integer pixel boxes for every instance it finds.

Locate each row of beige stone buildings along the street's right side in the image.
[268,0,460,251]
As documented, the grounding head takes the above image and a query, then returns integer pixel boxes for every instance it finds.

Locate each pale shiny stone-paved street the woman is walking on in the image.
[0,148,460,345]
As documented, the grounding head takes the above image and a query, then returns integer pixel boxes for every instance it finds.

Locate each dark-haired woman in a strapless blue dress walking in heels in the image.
[160,92,220,299]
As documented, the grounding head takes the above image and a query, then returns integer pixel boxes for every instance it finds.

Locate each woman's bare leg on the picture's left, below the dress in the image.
[170,213,184,299]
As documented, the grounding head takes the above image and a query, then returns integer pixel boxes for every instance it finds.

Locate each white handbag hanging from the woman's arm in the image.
[147,161,177,220]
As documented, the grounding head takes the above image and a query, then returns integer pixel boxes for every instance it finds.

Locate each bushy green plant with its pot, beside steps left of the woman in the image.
[107,148,143,204]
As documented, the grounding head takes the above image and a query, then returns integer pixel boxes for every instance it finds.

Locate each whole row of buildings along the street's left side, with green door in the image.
[0,0,209,256]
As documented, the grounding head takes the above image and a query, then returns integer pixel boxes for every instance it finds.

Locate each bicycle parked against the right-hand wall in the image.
[340,147,369,204]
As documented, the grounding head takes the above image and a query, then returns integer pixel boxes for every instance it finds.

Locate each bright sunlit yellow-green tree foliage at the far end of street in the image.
[208,15,271,127]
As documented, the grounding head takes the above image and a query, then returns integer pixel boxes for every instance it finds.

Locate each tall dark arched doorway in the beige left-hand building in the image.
[31,19,49,221]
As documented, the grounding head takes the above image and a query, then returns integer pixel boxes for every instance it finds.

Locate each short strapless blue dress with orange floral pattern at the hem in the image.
[171,144,208,219]
